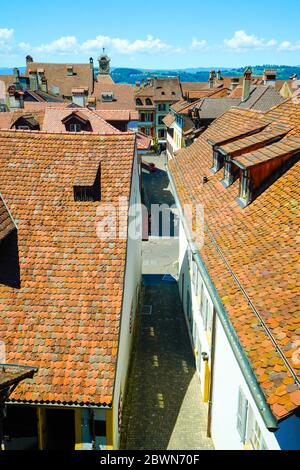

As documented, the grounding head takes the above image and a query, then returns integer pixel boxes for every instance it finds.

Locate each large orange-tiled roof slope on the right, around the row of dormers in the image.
[169,101,300,420]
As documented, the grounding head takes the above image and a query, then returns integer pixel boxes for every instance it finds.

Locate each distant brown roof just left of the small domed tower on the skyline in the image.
[25,62,94,96]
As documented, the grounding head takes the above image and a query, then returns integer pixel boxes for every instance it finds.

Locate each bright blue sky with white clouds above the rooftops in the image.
[0,0,300,69]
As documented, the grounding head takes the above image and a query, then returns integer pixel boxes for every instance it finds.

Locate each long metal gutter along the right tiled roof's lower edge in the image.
[166,165,279,432]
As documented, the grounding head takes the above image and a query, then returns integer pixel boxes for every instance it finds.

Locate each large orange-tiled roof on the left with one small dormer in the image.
[0,131,135,406]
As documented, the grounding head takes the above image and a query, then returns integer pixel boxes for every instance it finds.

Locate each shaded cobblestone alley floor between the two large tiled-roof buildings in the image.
[122,276,213,450]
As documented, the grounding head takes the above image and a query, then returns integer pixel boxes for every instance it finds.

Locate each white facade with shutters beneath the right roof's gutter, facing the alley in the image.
[169,170,300,450]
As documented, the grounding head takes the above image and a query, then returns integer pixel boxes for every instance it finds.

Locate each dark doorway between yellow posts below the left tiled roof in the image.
[46,409,75,450]
